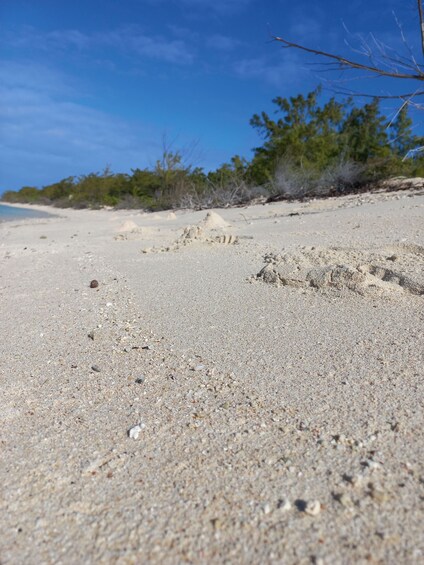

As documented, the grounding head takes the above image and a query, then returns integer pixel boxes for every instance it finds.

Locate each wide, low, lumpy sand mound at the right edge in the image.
[256,244,424,295]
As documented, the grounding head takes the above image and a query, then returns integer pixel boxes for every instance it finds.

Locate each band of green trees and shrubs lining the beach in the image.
[2,88,424,210]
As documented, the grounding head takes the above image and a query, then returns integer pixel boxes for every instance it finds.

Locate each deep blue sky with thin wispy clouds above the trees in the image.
[0,0,420,192]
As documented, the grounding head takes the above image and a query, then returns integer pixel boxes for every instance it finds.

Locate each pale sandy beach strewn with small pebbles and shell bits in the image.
[0,191,424,565]
